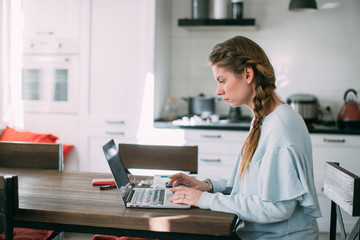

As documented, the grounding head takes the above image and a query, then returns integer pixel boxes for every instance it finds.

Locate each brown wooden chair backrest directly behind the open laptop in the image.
[119,144,198,173]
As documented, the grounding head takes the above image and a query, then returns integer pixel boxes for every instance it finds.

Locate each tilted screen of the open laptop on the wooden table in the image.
[103,140,132,203]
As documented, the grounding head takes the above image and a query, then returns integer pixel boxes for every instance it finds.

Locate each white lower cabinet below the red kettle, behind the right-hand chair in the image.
[311,134,360,232]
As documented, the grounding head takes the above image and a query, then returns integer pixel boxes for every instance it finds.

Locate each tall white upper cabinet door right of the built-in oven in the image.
[88,0,155,117]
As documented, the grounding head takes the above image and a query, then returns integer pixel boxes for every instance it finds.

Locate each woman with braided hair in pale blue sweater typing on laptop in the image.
[169,36,321,240]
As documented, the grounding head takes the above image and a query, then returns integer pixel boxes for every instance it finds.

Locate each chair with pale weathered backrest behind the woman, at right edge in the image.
[324,162,360,240]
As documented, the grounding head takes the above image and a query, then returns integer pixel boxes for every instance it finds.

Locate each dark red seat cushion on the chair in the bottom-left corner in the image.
[0,228,54,240]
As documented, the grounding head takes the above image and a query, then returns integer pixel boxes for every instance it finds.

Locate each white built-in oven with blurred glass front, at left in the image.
[21,37,80,113]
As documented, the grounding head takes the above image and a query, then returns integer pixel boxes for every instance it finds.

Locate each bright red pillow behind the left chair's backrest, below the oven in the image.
[0,127,74,159]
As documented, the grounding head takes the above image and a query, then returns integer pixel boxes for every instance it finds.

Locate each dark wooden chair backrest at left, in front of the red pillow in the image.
[0,142,63,170]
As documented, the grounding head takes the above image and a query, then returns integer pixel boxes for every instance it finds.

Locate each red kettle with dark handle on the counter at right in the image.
[338,89,360,128]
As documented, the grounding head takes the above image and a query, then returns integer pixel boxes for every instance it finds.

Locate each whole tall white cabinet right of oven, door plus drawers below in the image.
[79,0,155,172]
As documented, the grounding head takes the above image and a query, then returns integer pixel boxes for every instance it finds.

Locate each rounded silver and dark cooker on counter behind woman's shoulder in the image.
[286,94,319,126]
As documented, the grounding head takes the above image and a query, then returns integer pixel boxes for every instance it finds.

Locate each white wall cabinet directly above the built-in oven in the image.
[22,0,81,53]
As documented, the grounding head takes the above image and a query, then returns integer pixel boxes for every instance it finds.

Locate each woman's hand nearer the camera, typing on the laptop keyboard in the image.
[169,186,203,207]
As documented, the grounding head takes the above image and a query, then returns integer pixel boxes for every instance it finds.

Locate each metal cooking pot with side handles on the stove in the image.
[182,93,218,117]
